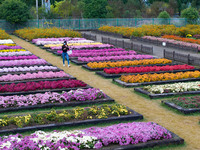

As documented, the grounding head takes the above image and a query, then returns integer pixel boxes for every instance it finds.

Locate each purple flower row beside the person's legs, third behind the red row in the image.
[70,51,136,57]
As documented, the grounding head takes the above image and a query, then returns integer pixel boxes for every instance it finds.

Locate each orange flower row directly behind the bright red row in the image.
[87,58,172,68]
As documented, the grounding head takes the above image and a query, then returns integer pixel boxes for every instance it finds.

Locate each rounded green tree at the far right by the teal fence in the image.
[181,7,199,23]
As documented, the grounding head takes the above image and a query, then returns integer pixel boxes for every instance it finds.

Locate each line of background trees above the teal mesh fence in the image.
[0,0,200,23]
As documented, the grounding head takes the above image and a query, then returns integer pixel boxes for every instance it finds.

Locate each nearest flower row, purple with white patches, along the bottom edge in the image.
[0,122,172,150]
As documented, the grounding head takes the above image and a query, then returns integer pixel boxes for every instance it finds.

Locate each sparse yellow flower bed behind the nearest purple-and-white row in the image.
[0,104,132,127]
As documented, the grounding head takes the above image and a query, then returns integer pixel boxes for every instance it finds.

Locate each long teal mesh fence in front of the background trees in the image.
[0,18,200,31]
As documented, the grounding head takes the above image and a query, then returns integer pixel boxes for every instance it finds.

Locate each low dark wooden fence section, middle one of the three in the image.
[101,37,153,55]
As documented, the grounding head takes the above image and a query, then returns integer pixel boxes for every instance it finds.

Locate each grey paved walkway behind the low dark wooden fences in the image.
[82,31,200,58]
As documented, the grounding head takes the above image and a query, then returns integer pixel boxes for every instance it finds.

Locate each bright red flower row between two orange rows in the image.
[103,64,195,74]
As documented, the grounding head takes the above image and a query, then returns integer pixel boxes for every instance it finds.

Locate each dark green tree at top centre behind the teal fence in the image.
[83,0,108,18]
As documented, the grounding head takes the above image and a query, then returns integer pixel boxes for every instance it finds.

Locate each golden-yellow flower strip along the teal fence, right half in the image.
[99,25,200,37]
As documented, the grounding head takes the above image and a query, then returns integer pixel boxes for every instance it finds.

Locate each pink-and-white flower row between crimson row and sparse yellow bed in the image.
[0,88,106,108]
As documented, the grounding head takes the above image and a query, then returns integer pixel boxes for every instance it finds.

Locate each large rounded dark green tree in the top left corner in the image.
[0,0,29,23]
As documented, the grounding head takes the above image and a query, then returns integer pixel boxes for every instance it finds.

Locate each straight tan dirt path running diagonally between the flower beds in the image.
[11,36,200,150]
